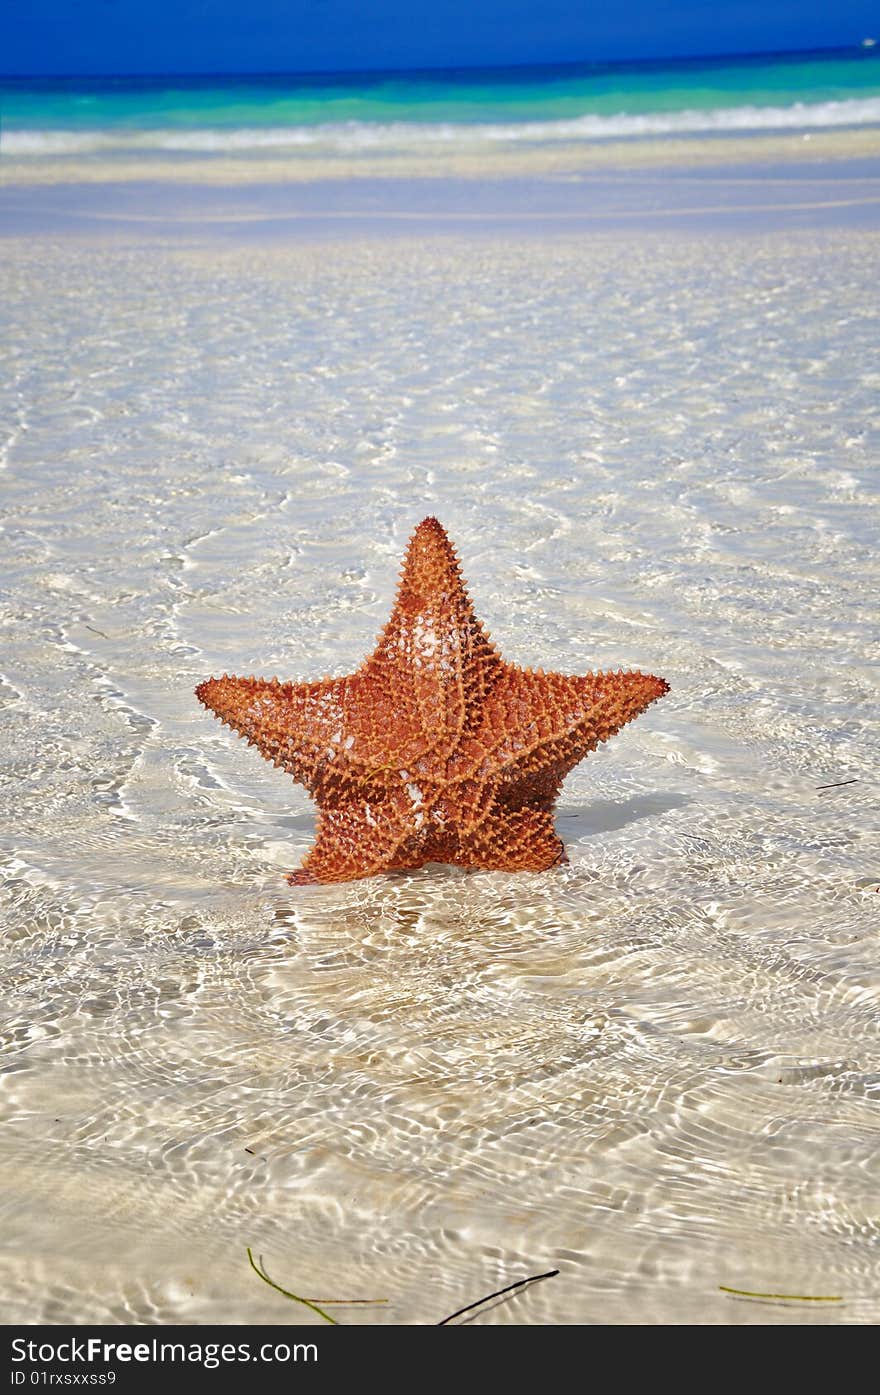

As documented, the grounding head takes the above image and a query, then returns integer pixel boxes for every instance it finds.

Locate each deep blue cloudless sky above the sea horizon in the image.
[0,0,880,75]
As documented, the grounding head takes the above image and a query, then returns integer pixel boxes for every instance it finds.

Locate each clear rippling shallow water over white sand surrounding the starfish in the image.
[0,171,880,1324]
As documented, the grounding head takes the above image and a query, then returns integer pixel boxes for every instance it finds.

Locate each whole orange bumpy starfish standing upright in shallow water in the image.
[195,518,668,886]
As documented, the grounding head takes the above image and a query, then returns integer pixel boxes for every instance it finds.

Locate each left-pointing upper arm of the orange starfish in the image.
[195,674,357,790]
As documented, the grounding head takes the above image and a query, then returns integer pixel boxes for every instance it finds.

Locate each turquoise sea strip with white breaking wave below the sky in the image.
[0,40,880,159]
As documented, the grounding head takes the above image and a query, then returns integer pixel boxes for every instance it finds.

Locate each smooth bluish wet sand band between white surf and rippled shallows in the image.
[0,142,880,243]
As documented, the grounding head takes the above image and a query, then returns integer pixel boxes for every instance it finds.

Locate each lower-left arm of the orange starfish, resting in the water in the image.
[287,804,425,886]
